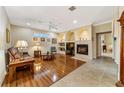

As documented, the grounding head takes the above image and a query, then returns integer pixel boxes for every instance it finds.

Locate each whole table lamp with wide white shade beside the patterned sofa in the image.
[16,40,28,60]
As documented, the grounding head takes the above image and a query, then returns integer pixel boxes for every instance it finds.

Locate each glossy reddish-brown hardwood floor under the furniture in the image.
[3,55,85,87]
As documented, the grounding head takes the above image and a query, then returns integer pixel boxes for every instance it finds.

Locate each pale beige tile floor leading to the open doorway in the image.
[51,57,117,87]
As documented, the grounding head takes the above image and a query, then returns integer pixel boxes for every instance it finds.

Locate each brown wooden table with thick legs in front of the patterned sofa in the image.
[8,57,35,83]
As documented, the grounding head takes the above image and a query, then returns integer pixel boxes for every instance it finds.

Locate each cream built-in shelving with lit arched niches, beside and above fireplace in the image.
[58,25,92,54]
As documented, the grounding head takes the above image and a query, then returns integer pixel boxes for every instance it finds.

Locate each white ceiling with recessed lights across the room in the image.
[4,6,114,32]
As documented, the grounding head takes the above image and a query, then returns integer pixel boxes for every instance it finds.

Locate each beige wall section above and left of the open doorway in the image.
[93,22,112,58]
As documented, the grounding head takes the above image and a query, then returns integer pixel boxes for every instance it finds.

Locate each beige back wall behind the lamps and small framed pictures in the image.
[11,26,57,56]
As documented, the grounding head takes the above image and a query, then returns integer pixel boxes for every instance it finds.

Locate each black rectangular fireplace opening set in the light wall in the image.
[77,44,88,55]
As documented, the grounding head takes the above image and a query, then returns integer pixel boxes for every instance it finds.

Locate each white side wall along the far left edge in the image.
[0,7,10,86]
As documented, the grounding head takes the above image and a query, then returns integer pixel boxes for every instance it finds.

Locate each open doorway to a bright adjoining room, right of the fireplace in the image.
[96,31,113,58]
